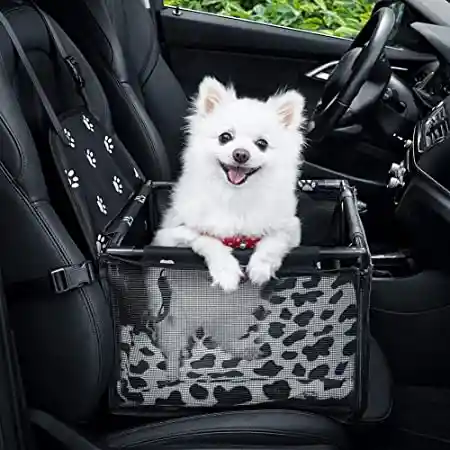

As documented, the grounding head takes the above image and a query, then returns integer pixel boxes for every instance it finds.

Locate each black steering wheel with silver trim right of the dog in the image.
[308,7,395,142]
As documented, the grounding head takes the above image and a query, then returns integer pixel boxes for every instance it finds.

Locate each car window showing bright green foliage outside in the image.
[164,0,376,38]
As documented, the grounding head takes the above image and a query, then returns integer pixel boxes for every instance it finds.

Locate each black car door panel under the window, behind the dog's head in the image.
[161,7,433,108]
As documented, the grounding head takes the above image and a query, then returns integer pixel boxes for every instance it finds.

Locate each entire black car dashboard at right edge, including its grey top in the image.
[370,18,450,267]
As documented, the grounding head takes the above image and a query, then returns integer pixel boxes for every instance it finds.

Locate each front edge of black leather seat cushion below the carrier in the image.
[103,410,348,450]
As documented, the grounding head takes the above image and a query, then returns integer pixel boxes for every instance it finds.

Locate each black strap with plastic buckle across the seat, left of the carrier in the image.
[5,261,97,298]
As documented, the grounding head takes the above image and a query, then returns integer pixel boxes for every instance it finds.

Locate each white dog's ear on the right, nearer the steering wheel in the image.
[267,89,305,130]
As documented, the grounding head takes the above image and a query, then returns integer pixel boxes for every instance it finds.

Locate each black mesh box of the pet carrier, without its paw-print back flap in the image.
[102,180,371,417]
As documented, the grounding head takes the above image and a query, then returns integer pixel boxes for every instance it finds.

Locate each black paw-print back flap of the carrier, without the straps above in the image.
[50,109,143,252]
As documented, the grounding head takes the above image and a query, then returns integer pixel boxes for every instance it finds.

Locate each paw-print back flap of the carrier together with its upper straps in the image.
[0,3,144,255]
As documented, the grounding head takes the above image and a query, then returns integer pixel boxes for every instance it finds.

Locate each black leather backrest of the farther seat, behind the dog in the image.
[37,0,188,180]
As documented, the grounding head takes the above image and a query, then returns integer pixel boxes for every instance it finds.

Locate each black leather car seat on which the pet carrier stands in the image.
[0,0,376,450]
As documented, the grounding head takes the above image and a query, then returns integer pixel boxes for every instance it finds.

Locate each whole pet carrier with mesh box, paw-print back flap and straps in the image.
[0,4,371,417]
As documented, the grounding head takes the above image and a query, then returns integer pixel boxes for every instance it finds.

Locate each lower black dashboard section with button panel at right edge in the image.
[389,96,450,267]
